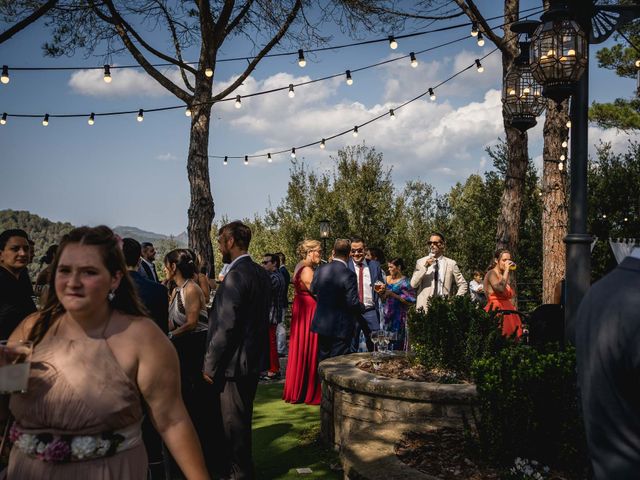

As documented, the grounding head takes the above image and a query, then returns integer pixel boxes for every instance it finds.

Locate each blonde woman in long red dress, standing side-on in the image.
[282,240,321,405]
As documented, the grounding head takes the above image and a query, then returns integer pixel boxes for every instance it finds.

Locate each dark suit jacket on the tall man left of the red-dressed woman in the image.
[203,256,271,382]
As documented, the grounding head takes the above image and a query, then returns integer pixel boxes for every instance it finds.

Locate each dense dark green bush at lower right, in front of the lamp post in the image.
[472,344,586,472]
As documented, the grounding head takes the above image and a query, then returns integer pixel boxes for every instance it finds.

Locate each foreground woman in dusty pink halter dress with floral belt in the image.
[2,226,208,480]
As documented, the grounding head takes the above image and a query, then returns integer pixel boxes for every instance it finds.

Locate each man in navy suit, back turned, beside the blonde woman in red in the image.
[311,239,364,362]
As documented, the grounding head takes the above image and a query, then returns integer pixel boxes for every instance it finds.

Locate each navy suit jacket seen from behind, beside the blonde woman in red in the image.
[311,261,363,338]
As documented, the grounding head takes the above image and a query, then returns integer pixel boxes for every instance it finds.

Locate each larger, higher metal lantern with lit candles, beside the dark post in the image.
[530,2,589,103]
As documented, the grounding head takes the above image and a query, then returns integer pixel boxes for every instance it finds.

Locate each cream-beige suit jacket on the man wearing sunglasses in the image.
[411,257,468,310]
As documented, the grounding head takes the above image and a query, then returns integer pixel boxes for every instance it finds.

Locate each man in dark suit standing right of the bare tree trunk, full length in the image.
[203,221,271,480]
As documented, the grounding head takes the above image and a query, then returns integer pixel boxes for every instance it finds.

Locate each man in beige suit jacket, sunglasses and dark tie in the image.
[411,233,467,310]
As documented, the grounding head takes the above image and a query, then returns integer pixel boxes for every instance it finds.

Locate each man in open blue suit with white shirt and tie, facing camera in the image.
[348,237,384,352]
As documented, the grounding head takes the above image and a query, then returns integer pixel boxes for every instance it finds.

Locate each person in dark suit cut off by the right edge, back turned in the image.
[576,248,640,480]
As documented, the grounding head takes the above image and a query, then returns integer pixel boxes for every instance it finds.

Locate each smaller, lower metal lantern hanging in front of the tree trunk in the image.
[502,42,547,132]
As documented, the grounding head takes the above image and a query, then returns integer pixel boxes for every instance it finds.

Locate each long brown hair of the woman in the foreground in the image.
[29,225,148,345]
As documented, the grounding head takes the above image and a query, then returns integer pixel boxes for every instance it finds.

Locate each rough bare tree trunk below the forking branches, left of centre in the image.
[187,93,214,273]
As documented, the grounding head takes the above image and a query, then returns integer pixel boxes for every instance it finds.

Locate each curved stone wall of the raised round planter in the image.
[318,353,477,449]
